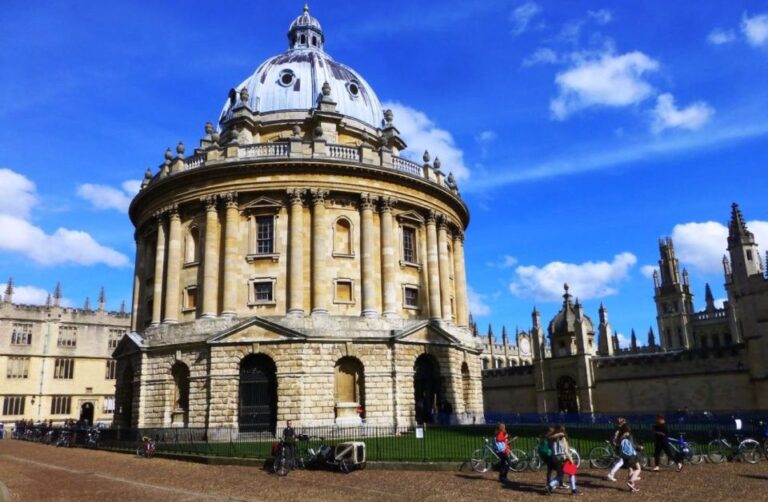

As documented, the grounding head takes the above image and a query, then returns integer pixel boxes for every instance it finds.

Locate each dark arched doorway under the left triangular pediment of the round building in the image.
[239,354,277,432]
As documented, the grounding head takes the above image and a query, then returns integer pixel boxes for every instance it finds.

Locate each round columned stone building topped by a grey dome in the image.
[115,8,483,431]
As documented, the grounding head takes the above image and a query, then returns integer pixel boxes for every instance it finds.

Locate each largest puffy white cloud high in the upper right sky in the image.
[549,51,659,120]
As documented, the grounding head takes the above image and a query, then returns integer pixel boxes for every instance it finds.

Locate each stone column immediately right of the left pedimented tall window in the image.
[288,188,305,317]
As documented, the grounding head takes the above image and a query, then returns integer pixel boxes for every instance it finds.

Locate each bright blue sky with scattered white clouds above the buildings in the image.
[0,0,768,339]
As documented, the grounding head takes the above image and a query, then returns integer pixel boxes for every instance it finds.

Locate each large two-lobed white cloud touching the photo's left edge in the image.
[0,169,128,267]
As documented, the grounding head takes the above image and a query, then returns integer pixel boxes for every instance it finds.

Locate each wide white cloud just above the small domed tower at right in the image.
[509,252,637,301]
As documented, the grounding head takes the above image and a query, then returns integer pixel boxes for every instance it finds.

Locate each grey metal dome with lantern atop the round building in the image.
[220,6,384,127]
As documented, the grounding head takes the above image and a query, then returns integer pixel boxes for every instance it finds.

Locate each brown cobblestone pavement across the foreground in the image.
[0,440,768,502]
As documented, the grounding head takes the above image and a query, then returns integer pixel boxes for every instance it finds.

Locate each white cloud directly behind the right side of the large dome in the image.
[383,102,469,181]
